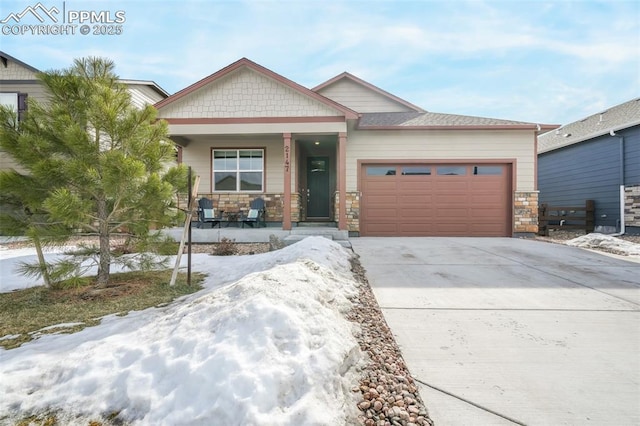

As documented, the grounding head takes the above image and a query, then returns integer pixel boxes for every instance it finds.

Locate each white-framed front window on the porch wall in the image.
[213,149,264,192]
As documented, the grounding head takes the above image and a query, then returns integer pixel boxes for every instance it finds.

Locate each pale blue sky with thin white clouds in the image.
[0,0,640,124]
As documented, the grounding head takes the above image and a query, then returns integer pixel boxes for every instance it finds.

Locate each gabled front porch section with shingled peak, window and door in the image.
[155,58,358,230]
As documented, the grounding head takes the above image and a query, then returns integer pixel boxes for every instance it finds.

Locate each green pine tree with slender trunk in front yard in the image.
[0,58,185,287]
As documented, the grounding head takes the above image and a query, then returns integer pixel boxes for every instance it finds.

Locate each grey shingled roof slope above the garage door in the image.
[358,112,557,131]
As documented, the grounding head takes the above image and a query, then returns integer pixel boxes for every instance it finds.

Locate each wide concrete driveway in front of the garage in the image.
[351,237,640,426]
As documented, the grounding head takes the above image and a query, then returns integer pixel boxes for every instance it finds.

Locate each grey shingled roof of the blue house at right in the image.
[538,98,640,154]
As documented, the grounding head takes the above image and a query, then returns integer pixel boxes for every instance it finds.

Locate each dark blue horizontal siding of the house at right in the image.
[538,135,621,227]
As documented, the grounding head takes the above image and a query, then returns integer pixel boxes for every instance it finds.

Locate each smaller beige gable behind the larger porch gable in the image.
[317,78,415,113]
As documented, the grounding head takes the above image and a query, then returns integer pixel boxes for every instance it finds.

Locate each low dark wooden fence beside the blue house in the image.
[538,200,596,235]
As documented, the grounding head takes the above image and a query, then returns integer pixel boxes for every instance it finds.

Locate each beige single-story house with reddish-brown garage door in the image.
[155,58,557,236]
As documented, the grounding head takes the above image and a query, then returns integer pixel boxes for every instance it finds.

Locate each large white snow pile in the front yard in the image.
[0,237,362,425]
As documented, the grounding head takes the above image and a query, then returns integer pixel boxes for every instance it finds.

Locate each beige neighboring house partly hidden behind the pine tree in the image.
[0,51,169,170]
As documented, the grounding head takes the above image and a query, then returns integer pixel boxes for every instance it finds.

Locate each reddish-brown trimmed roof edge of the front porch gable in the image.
[155,58,358,119]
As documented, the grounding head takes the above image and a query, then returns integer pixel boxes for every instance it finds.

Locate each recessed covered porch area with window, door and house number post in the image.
[168,125,348,231]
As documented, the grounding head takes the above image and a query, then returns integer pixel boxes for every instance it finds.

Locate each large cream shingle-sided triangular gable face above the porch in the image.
[158,67,344,118]
